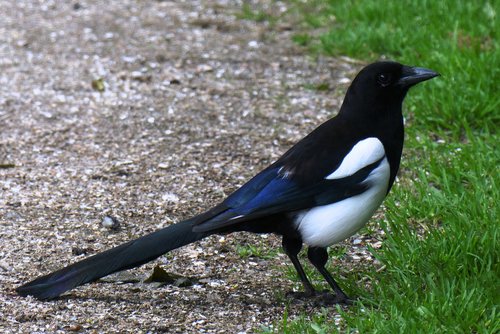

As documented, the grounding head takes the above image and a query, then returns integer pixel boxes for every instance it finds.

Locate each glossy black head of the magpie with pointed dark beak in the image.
[344,61,439,118]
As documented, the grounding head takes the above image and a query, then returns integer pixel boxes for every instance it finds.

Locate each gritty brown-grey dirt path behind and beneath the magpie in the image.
[0,0,371,333]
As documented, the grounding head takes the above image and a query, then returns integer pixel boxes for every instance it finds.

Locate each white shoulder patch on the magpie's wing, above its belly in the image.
[326,137,385,180]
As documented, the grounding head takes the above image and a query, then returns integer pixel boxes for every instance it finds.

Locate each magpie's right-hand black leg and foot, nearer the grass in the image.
[307,247,351,304]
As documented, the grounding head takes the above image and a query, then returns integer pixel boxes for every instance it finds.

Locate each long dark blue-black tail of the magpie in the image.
[16,219,212,300]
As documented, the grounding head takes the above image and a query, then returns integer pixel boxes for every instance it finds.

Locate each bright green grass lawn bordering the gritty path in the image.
[252,0,500,333]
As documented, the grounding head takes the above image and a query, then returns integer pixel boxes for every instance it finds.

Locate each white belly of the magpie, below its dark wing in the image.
[295,158,390,247]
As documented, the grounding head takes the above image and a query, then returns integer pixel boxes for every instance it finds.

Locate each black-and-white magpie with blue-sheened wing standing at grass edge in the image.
[16,61,439,304]
